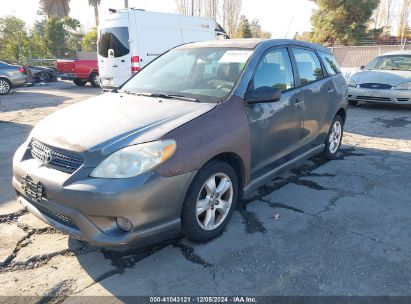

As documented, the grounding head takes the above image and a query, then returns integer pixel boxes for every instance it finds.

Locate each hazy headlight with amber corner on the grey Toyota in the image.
[90,140,176,178]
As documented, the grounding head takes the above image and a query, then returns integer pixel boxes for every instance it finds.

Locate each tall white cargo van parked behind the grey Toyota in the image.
[98,9,228,88]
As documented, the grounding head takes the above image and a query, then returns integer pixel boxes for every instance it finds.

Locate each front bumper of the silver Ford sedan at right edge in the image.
[348,88,411,104]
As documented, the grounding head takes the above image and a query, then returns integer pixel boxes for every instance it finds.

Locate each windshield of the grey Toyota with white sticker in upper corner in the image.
[121,48,253,102]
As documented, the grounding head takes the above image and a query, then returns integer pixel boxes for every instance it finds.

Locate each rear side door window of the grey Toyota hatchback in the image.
[292,48,324,85]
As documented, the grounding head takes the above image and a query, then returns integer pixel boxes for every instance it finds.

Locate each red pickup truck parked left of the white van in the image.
[57,59,100,88]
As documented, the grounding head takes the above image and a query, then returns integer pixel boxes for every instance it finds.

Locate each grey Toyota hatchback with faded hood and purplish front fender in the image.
[13,39,347,246]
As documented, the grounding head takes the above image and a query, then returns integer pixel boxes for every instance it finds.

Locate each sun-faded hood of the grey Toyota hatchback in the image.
[31,93,216,153]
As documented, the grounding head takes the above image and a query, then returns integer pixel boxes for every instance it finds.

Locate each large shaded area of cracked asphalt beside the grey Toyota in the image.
[72,147,411,297]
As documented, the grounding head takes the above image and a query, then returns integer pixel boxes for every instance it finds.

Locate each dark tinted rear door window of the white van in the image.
[98,27,130,58]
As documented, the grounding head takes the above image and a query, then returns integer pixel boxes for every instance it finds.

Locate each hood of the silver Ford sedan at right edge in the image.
[351,70,411,86]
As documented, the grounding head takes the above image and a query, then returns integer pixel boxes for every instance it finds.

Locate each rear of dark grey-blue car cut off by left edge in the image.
[0,61,27,95]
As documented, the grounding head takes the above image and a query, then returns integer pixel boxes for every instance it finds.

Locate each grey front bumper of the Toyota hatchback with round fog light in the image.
[13,147,195,246]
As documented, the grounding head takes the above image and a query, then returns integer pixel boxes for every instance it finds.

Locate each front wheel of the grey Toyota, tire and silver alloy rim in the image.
[181,160,239,242]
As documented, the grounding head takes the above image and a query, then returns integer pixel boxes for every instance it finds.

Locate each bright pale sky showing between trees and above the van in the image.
[0,0,315,38]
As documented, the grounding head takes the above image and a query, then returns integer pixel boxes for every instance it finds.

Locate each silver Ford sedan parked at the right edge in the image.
[348,51,411,106]
